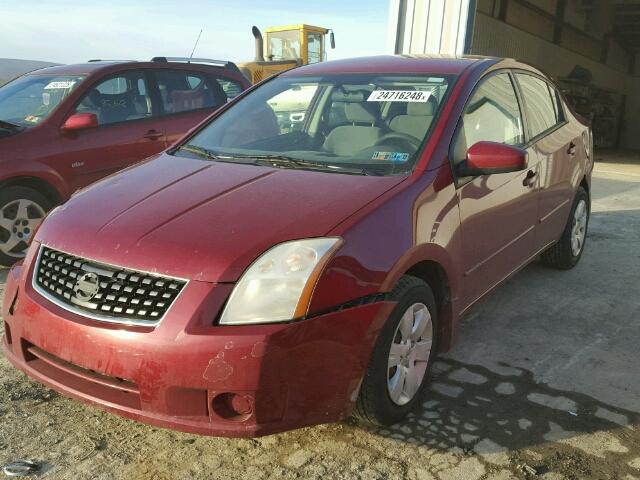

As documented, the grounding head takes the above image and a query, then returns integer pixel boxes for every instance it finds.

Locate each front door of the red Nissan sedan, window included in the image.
[451,71,539,306]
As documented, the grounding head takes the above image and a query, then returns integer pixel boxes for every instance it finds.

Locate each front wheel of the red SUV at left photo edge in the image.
[0,186,51,267]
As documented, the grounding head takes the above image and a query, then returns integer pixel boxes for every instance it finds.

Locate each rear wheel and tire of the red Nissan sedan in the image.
[542,187,591,270]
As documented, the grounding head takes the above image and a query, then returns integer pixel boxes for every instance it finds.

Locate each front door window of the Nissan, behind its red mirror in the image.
[453,73,524,164]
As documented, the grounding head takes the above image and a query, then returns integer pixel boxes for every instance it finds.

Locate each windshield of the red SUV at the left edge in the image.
[0,75,84,127]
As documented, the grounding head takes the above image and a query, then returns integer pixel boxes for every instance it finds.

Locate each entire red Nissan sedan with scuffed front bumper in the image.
[3,56,593,436]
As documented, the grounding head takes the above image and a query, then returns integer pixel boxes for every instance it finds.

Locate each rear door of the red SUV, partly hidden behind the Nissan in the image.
[153,68,244,145]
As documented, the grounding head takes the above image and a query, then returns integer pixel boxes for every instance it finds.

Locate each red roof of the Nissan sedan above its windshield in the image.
[282,55,501,76]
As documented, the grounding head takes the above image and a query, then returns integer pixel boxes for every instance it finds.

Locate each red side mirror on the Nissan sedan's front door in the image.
[457,142,527,177]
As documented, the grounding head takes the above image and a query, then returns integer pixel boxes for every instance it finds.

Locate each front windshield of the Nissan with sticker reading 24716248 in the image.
[179,74,452,175]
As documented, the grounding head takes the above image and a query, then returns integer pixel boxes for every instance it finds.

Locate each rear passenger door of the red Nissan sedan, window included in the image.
[515,72,581,250]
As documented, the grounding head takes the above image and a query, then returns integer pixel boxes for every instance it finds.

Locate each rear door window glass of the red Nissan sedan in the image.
[516,73,559,137]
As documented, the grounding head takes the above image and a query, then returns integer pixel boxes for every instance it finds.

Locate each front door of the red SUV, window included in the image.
[56,70,165,189]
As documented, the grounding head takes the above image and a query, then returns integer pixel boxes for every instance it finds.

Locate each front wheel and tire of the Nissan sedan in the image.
[353,275,438,426]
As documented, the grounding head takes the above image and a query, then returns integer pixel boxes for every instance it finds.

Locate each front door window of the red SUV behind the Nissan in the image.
[76,72,152,125]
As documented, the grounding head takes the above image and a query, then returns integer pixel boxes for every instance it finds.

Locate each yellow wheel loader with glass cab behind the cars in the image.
[238,24,335,83]
